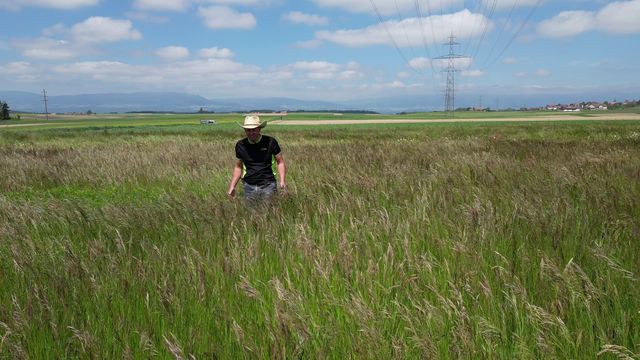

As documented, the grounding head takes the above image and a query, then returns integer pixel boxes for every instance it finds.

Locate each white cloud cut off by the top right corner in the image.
[538,0,640,39]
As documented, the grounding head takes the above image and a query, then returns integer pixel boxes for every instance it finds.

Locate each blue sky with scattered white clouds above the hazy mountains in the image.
[0,0,640,107]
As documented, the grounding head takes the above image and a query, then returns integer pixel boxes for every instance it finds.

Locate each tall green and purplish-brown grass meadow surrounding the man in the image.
[0,121,640,359]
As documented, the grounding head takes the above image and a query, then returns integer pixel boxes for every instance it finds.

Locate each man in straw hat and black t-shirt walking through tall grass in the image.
[227,116,287,205]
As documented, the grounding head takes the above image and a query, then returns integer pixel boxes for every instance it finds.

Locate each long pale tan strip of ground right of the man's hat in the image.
[269,114,640,125]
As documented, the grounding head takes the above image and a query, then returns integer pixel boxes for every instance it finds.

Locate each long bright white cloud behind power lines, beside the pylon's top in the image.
[315,9,494,47]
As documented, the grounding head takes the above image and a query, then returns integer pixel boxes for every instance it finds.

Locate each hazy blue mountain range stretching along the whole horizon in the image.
[0,89,633,114]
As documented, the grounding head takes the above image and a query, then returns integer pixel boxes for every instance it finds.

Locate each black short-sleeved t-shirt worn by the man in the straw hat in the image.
[236,135,282,185]
